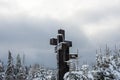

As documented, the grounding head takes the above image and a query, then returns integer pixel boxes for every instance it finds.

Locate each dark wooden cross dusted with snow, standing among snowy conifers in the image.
[50,29,72,80]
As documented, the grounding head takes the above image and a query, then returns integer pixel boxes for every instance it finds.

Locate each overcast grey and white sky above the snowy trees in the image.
[0,0,120,67]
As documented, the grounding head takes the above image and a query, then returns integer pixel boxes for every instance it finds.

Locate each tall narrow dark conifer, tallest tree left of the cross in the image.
[5,51,15,80]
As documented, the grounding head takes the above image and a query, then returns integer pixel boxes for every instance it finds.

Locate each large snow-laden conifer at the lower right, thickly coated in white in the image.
[92,46,119,80]
